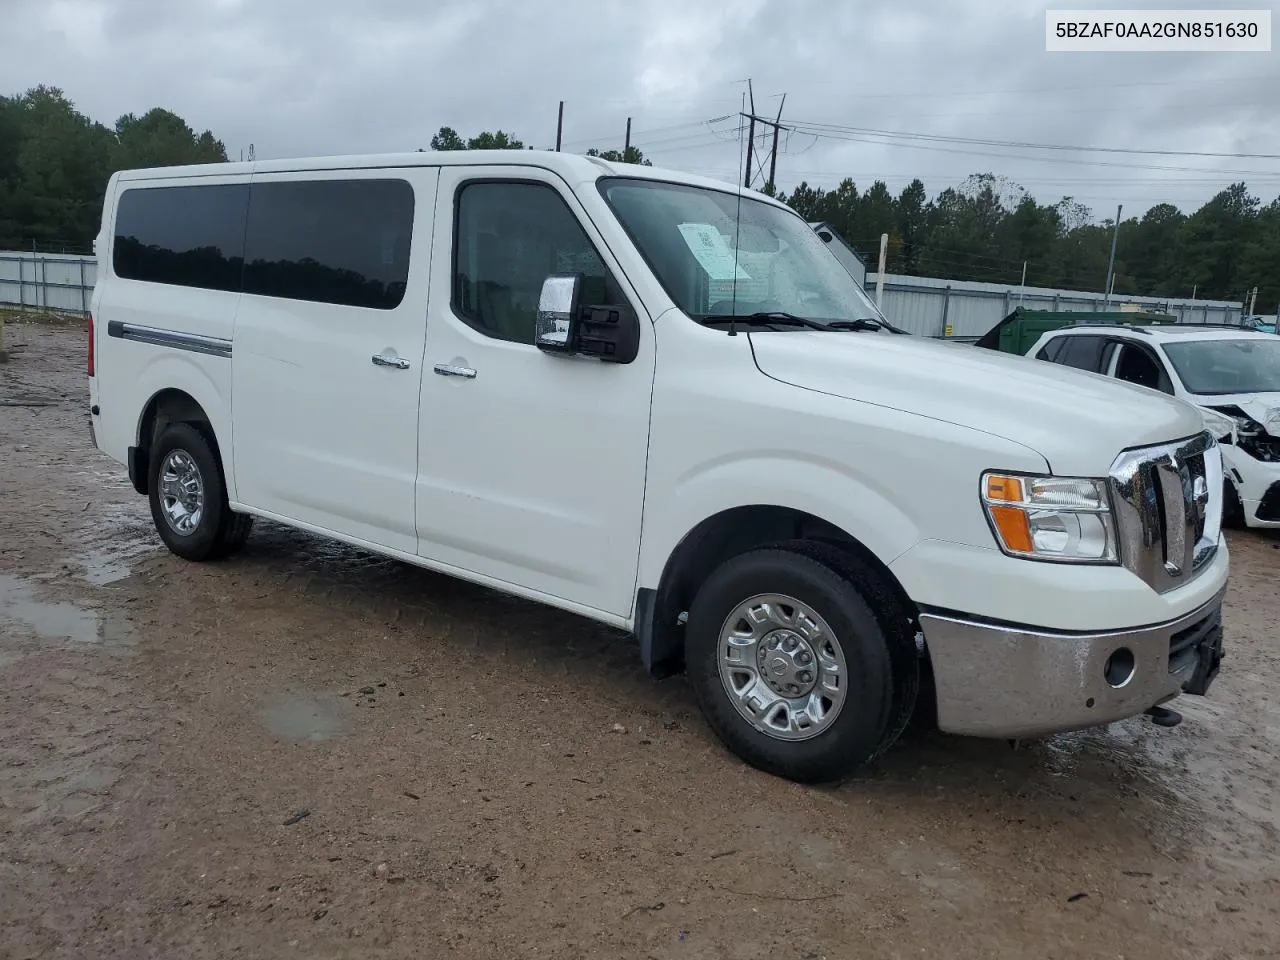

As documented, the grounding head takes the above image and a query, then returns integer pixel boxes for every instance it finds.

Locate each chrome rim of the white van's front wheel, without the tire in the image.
[717,594,847,740]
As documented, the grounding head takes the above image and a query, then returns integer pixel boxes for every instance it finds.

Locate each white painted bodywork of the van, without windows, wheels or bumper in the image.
[91,151,1228,680]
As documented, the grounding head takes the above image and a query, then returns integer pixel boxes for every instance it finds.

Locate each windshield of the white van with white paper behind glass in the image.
[600,178,883,324]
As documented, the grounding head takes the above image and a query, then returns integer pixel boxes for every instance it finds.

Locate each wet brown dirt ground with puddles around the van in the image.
[0,324,1280,960]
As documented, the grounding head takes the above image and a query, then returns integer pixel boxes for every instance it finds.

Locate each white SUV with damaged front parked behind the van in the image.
[1027,324,1280,527]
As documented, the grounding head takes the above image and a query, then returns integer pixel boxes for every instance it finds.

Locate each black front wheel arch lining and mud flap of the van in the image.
[635,503,916,677]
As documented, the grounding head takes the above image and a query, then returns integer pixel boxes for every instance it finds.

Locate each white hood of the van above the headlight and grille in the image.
[750,330,1204,476]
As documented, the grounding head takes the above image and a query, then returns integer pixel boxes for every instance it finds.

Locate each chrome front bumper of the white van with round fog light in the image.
[920,588,1225,739]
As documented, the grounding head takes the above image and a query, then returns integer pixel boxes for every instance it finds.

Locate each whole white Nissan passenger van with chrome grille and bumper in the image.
[88,151,1228,781]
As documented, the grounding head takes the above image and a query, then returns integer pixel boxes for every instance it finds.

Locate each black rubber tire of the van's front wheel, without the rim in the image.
[685,543,919,782]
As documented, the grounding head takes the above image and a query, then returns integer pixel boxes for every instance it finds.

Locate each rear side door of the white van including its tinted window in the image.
[233,168,439,553]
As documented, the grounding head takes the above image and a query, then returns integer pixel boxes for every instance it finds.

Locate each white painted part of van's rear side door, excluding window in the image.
[232,168,448,554]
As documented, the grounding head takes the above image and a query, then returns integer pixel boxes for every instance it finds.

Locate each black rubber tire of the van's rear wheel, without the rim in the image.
[147,424,253,562]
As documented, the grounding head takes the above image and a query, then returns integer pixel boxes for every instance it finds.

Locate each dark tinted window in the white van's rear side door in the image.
[244,179,413,310]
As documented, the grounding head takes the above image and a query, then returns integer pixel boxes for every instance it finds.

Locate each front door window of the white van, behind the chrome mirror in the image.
[453,182,623,344]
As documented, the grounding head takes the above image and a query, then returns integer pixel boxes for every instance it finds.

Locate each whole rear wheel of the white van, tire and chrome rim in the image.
[147,424,253,561]
